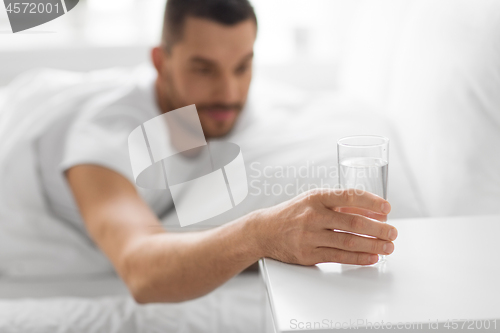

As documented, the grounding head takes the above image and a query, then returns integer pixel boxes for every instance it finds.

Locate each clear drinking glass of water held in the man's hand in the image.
[337,135,389,263]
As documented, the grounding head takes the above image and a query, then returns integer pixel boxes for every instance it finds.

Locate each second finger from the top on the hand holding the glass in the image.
[325,211,398,241]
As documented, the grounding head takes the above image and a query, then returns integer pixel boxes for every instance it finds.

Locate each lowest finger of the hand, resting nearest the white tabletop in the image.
[312,247,378,265]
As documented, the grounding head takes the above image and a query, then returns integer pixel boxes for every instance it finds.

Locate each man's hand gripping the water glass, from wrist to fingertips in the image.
[256,189,397,265]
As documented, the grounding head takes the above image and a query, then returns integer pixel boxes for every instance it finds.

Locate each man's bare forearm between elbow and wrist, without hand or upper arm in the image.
[123,211,263,303]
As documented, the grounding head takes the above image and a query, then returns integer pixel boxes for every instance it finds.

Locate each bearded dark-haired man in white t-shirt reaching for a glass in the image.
[41,0,397,303]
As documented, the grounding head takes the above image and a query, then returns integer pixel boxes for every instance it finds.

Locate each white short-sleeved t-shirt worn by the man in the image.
[36,67,173,234]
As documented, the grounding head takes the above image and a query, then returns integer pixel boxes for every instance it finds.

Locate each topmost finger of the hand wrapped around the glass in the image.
[314,189,391,214]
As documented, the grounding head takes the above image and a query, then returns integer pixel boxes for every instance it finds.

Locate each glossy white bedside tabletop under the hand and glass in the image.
[260,215,500,332]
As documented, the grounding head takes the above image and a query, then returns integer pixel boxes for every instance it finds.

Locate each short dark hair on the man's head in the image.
[161,0,257,51]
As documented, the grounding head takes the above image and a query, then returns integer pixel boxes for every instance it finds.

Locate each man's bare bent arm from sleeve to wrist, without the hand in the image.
[67,165,260,303]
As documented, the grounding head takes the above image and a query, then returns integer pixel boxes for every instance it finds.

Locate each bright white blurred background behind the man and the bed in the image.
[0,0,500,216]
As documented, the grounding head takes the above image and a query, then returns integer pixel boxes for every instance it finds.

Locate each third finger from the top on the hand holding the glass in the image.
[316,230,394,254]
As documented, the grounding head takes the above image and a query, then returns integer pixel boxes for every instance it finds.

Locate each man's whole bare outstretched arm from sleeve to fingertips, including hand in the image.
[66,165,397,303]
